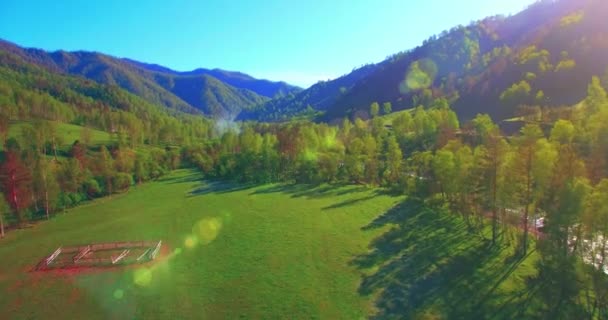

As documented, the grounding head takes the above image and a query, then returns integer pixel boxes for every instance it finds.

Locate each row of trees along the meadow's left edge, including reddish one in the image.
[0,120,181,234]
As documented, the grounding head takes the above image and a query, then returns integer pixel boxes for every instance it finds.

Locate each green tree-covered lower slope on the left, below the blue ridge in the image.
[0,51,210,144]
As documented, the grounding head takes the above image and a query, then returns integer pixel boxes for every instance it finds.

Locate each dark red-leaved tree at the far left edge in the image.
[0,151,32,224]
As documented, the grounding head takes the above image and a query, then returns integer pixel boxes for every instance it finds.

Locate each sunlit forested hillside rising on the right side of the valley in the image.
[243,0,608,121]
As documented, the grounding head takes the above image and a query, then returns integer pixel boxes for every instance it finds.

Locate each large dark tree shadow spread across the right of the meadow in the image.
[351,200,532,319]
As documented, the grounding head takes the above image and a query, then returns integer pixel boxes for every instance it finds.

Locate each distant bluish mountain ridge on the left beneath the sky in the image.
[0,40,301,117]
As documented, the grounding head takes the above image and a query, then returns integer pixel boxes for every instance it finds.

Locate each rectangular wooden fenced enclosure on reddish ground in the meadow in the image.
[36,241,162,270]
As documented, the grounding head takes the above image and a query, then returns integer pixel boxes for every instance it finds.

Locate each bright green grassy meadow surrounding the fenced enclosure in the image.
[0,170,534,319]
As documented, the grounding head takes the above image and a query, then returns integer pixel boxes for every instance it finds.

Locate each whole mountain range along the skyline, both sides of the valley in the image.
[0,0,608,122]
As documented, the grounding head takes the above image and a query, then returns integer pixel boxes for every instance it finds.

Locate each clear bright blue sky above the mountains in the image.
[0,0,532,87]
